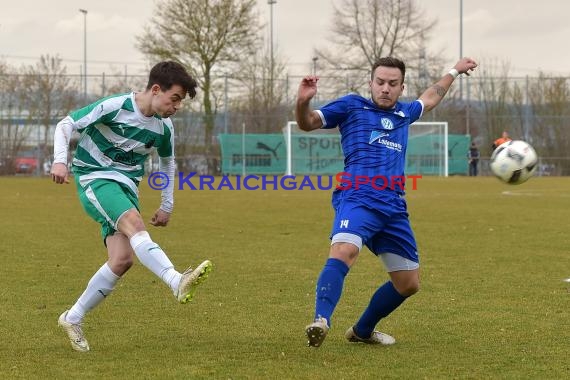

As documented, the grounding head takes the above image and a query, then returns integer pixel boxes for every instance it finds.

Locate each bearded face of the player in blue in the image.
[370,66,404,108]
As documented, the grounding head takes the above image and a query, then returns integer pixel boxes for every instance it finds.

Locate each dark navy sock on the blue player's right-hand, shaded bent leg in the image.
[354,281,408,338]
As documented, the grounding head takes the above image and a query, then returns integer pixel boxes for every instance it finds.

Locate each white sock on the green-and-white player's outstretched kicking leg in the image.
[130,231,182,291]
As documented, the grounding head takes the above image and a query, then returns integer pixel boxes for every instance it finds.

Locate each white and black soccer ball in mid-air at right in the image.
[490,140,538,185]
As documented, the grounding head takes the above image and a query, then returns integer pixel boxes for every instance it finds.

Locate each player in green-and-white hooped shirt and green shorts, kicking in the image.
[51,61,212,352]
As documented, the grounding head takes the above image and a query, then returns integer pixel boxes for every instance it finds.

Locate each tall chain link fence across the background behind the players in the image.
[0,72,570,176]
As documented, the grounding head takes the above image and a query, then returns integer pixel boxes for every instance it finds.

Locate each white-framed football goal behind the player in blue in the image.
[283,121,448,177]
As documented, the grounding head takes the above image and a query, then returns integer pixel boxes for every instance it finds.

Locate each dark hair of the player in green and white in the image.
[146,61,197,99]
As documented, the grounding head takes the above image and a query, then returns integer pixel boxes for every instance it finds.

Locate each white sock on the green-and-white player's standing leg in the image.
[65,263,120,324]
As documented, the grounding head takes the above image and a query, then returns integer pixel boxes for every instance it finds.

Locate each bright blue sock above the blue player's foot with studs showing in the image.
[315,258,350,326]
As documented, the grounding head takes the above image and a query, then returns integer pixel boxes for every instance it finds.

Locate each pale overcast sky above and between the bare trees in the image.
[0,0,570,76]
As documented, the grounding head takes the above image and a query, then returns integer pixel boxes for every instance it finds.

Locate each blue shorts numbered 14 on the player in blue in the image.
[330,190,419,263]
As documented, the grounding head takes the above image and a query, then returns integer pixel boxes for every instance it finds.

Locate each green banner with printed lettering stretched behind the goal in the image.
[219,134,470,175]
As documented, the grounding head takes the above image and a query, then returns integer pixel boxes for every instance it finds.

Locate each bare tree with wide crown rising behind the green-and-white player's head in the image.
[137,0,260,173]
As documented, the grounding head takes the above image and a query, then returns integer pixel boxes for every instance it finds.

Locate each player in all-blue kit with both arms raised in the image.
[296,57,477,347]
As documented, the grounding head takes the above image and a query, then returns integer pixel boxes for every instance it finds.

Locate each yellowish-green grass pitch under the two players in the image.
[0,177,570,380]
